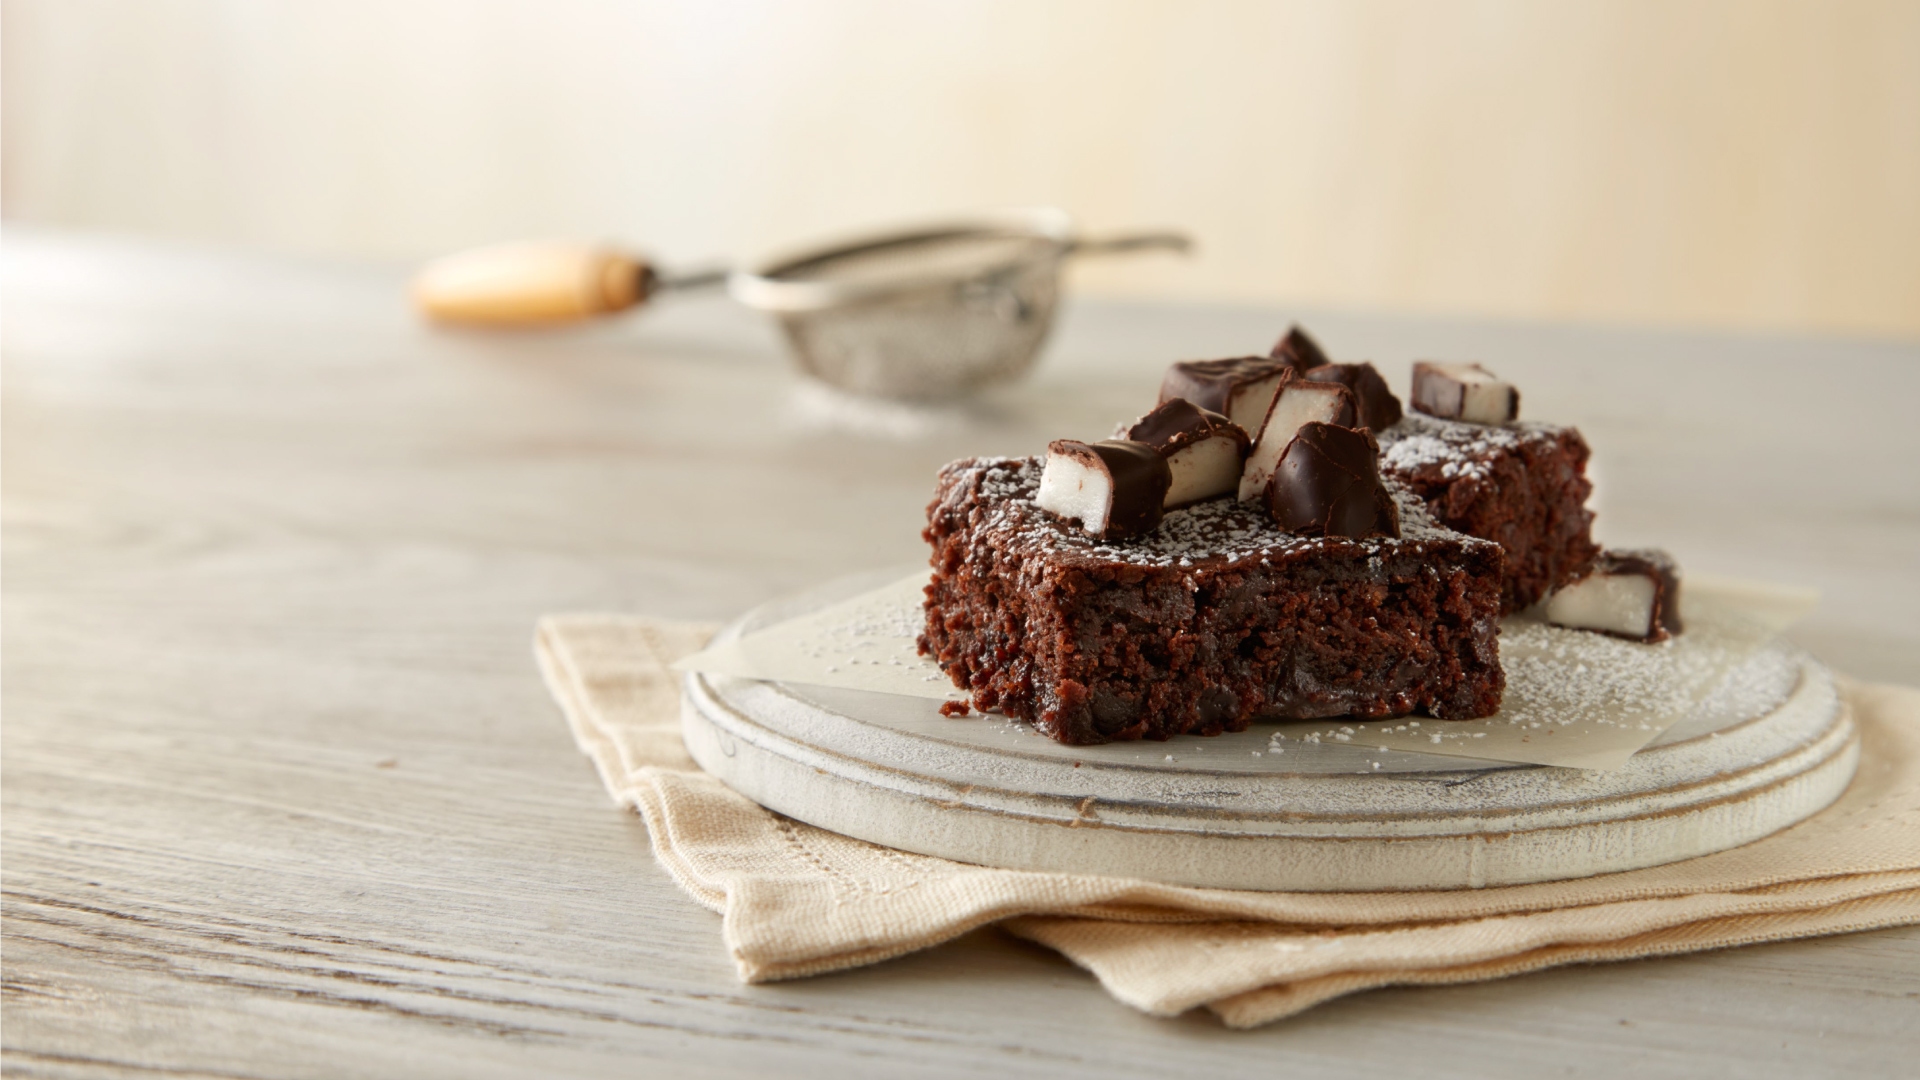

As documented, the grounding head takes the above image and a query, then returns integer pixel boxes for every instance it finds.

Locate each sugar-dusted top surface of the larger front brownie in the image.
[941,457,1484,569]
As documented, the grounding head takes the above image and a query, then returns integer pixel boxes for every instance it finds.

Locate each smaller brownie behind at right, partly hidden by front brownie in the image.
[1379,413,1599,613]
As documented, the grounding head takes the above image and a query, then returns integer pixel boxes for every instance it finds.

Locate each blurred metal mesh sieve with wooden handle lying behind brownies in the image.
[415,208,1188,400]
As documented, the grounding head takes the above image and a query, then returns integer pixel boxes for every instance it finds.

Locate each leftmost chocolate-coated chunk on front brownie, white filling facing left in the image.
[1033,438,1173,540]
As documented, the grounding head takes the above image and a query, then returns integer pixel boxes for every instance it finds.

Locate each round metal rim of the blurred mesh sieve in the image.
[728,206,1075,313]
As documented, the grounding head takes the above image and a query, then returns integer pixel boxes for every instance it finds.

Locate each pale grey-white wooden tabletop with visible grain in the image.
[0,231,1920,1076]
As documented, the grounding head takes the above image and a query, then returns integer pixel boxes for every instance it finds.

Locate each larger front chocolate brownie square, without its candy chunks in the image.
[920,457,1505,744]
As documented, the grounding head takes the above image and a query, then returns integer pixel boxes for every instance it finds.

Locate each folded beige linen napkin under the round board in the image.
[534,615,1920,1026]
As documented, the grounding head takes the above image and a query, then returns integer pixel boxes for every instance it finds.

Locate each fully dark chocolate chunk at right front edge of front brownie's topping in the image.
[1267,423,1400,538]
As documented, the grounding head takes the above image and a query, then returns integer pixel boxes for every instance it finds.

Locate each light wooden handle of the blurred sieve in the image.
[413,244,653,327]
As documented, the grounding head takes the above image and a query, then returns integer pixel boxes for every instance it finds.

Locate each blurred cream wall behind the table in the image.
[11,0,1920,336]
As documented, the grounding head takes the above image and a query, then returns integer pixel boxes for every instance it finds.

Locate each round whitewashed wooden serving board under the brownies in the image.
[682,582,1859,892]
